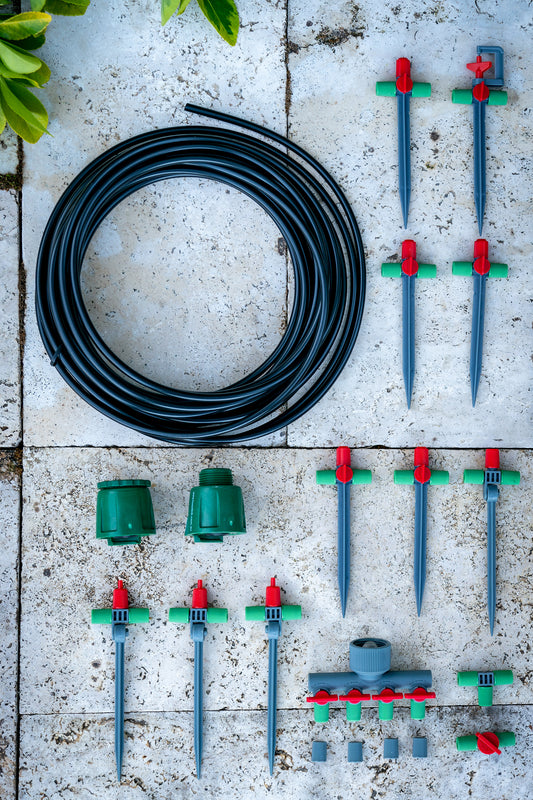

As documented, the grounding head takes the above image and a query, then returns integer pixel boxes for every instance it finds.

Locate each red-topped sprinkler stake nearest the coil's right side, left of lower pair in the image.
[381,239,437,408]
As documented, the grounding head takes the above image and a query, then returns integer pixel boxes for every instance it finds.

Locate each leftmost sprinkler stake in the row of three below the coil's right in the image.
[316,447,372,617]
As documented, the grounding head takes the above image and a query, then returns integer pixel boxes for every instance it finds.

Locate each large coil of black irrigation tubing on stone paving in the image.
[36,105,365,446]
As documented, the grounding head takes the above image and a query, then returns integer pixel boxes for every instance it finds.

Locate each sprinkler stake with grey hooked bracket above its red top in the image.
[452,45,507,236]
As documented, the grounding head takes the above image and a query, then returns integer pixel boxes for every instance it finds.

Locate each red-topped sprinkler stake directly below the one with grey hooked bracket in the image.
[452,239,508,406]
